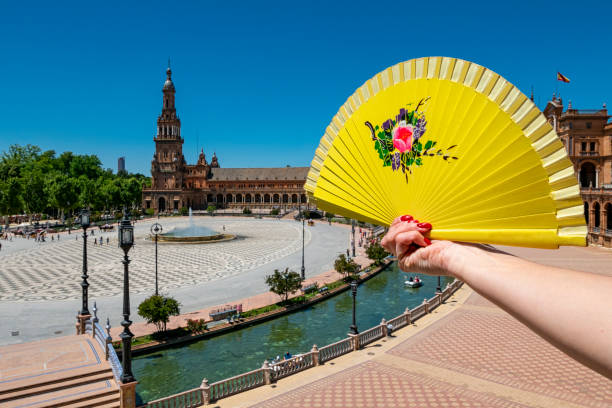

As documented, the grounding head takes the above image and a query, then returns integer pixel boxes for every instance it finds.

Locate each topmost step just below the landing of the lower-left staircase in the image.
[0,364,112,401]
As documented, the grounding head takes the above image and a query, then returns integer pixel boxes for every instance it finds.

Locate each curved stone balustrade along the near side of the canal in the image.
[139,280,463,408]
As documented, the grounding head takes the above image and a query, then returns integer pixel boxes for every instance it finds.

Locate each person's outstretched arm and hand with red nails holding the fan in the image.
[382,216,612,379]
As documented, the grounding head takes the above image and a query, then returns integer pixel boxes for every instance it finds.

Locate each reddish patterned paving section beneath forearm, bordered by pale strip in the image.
[388,295,612,407]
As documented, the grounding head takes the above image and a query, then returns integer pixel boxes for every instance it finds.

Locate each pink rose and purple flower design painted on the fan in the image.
[365,97,458,182]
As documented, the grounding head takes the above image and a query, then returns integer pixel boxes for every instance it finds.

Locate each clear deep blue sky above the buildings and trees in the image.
[0,0,612,175]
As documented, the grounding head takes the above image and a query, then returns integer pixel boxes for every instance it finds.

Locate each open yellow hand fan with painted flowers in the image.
[305,57,587,248]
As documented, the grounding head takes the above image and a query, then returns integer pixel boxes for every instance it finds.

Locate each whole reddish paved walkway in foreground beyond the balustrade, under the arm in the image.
[214,248,612,408]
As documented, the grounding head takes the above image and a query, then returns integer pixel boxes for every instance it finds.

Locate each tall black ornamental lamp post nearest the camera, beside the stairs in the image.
[119,208,135,384]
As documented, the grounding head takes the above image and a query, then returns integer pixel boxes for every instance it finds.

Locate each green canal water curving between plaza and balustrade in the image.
[132,263,451,402]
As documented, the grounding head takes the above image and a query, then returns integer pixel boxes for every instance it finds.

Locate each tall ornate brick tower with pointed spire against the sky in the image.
[151,61,185,190]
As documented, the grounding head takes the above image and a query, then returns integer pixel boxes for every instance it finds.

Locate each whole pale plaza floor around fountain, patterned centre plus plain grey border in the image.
[0,216,349,345]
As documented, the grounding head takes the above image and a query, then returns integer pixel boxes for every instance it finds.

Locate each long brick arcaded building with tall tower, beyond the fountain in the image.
[142,68,308,214]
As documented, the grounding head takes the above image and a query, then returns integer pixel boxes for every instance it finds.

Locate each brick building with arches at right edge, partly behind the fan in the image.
[544,96,612,247]
